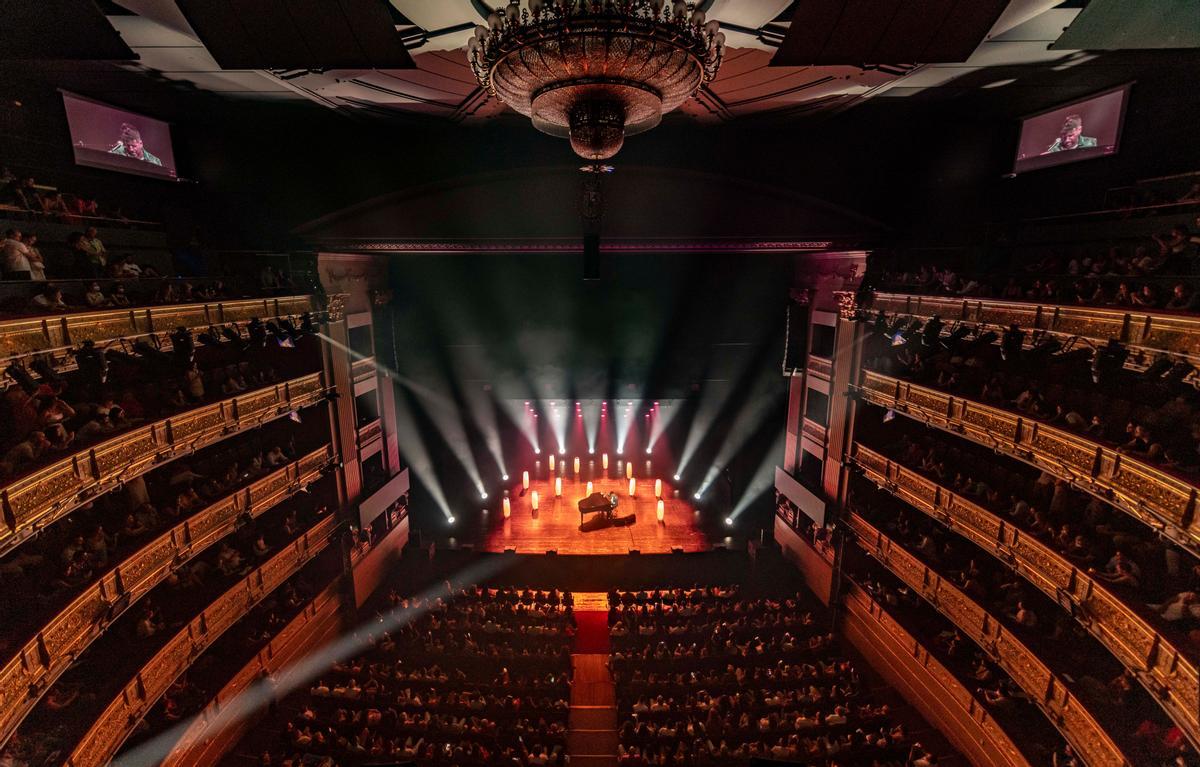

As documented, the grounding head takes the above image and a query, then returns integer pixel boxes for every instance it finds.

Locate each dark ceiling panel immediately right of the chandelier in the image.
[772,0,1008,66]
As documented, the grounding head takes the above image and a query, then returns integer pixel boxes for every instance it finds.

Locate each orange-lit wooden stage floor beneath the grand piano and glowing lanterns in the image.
[481,478,709,555]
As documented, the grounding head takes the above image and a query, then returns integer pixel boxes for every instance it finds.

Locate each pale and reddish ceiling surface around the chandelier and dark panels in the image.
[105,0,1082,124]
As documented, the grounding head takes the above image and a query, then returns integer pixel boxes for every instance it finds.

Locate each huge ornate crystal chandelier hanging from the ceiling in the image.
[467,0,725,162]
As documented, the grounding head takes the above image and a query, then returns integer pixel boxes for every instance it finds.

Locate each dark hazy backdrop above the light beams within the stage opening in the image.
[391,253,793,399]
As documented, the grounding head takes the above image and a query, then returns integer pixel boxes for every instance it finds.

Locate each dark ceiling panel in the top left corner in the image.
[0,0,138,61]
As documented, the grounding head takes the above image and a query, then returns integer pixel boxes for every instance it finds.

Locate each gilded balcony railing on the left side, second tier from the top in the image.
[0,373,325,556]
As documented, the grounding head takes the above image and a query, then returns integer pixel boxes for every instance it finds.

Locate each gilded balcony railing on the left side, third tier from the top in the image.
[0,445,334,744]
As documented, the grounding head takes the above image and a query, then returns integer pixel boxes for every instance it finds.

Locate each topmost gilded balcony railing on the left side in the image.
[0,295,313,367]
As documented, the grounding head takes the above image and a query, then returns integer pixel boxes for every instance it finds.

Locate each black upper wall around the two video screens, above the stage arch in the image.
[0,50,1200,247]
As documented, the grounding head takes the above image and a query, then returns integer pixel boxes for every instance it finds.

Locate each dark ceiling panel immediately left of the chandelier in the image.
[176,0,415,70]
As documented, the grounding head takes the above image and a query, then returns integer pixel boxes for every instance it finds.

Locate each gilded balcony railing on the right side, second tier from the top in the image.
[858,371,1200,553]
